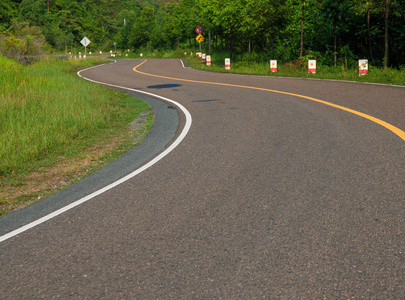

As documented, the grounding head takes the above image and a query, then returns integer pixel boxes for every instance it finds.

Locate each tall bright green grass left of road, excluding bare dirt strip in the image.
[0,56,149,176]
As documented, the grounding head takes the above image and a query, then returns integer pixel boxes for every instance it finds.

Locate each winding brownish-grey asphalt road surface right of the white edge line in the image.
[0,60,405,299]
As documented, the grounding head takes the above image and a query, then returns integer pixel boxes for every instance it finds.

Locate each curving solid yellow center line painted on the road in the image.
[133,60,405,141]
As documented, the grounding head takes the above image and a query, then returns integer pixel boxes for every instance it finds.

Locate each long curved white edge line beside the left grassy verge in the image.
[0,61,192,243]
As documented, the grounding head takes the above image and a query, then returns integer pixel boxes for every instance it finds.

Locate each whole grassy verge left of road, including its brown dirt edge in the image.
[0,57,153,215]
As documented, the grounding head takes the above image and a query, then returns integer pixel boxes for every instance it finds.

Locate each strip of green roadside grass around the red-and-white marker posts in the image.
[121,49,405,86]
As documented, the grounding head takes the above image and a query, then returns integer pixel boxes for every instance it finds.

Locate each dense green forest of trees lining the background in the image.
[0,0,405,68]
